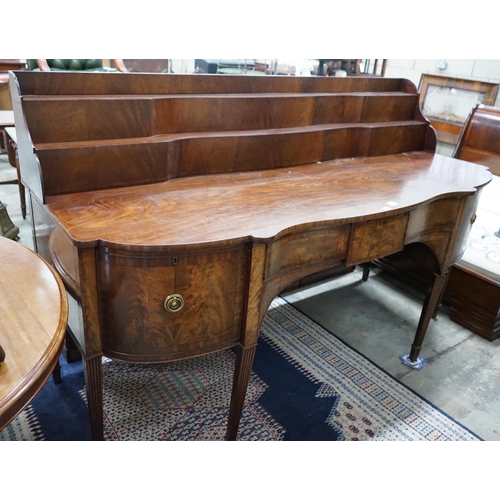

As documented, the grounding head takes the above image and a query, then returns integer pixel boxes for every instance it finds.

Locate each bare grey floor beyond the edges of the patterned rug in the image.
[0,155,500,441]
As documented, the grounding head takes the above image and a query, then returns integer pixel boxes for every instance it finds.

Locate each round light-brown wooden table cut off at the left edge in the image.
[0,237,68,430]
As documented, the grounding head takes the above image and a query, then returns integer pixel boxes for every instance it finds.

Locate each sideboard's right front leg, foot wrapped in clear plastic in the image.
[401,272,448,370]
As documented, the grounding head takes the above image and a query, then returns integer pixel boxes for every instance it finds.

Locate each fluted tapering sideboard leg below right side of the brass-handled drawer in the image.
[226,346,257,441]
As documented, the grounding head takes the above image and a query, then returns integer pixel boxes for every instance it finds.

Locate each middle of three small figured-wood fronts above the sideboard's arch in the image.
[346,215,408,266]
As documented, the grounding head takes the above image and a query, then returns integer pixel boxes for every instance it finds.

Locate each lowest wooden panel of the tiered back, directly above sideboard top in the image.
[38,122,428,196]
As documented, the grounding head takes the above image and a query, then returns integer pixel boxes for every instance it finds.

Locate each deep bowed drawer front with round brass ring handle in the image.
[98,246,247,362]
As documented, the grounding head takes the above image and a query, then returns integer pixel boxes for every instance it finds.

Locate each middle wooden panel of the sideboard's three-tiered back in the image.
[24,93,418,146]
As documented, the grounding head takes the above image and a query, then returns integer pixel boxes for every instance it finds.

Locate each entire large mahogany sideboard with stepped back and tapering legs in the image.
[11,72,491,439]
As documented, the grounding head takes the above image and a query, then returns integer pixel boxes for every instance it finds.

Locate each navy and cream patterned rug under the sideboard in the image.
[0,298,481,441]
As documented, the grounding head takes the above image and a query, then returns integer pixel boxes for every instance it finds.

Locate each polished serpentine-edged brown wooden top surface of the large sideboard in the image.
[47,152,491,250]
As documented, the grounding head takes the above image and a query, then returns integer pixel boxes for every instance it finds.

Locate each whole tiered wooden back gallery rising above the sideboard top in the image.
[9,73,435,200]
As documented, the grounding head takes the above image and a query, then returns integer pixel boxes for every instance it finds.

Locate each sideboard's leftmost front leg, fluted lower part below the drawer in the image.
[83,356,104,441]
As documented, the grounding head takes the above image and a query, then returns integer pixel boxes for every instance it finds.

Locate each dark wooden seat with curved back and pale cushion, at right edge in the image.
[365,105,500,340]
